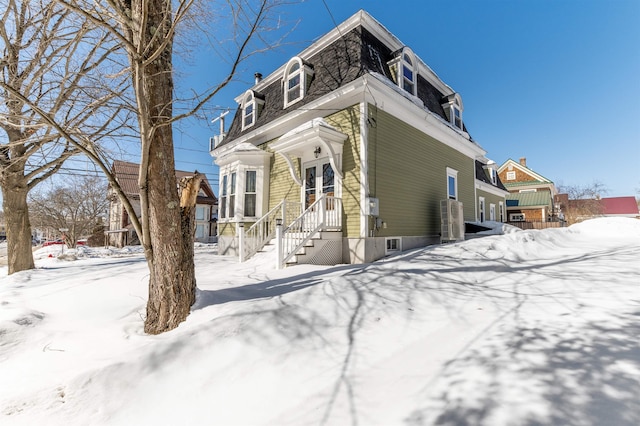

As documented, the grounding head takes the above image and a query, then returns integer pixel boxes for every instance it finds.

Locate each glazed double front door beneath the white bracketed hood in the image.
[304,159,337,226]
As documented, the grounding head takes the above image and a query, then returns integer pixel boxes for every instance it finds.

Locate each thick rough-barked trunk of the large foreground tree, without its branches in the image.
[140,0,196,334]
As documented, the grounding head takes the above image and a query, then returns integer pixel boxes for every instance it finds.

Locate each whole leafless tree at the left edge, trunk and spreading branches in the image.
[0,0,128,274]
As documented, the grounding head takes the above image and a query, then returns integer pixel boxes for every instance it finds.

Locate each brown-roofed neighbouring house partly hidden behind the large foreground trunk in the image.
[106,161,218,247]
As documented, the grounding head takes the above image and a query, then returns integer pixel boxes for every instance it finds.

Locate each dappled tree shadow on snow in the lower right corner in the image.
[405,312,640,426]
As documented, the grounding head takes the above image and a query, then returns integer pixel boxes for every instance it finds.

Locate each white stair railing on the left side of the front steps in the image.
[240,200,302,262]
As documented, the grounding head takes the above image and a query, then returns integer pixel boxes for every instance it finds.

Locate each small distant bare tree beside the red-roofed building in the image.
[558,182,608,225]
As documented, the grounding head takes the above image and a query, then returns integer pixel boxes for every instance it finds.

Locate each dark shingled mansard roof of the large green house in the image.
[220,10,466,150]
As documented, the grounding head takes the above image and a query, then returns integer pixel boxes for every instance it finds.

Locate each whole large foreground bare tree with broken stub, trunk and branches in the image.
[53,0,288,334]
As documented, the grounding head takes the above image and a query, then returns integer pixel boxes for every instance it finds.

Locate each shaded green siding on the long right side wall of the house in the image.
[368,105,475,236]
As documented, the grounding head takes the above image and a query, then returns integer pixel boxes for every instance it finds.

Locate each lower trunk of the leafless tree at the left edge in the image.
[2,175,34,275]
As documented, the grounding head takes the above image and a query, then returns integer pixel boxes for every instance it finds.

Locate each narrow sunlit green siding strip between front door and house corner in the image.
[325,104,360,237]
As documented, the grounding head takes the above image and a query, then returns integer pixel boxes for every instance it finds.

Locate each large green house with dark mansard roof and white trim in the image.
[211,11,507,267]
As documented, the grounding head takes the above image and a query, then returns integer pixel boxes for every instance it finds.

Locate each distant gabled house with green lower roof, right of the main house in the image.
[498,158,560,223]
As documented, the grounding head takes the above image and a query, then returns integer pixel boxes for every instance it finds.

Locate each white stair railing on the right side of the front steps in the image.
[276,195,342,269]
